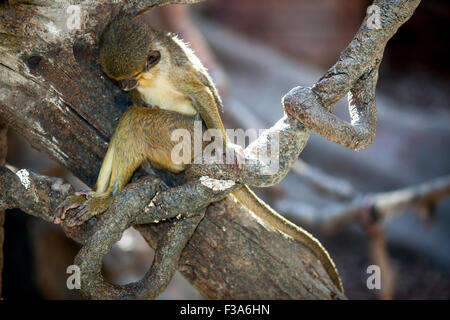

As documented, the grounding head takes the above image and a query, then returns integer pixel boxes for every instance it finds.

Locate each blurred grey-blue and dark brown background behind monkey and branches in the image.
[3,0,450,299]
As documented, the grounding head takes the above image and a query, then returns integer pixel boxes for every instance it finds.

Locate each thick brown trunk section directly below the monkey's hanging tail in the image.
[137,197,344,299]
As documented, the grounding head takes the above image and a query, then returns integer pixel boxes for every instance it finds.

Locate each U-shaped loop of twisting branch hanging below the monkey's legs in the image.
[75,178,204,299]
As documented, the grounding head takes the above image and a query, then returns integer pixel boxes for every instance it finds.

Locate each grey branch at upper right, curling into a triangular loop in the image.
[283,0,420,150]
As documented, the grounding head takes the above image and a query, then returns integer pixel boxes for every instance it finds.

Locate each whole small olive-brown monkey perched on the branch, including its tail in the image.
[55,18,343,291]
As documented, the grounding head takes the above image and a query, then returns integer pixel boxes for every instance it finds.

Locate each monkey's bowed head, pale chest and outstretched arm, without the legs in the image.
[100,14,236,151]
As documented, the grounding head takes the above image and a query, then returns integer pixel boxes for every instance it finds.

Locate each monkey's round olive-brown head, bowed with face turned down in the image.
[100,17,161,91]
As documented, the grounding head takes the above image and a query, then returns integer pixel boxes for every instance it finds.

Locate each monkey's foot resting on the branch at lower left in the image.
[64,195,114,227]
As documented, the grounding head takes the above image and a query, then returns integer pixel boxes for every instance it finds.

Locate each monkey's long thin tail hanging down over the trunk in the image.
[232,185,344,292]
